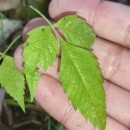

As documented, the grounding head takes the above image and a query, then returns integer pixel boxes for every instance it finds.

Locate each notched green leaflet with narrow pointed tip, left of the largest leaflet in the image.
[23,26,58,100]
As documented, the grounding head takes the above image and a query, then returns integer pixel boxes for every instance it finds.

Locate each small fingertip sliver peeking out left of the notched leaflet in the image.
[14,44,23,71]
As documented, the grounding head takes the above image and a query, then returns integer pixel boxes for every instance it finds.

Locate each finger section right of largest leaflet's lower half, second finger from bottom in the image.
[105,81,130,128]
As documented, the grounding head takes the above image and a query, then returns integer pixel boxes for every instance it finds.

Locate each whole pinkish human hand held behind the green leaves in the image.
[14,0,130,130]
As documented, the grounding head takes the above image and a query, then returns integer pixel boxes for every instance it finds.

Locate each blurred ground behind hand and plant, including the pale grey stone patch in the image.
[0,0,130,130]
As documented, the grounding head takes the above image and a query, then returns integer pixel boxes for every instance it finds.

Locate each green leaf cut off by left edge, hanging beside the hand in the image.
[0,56,25,111]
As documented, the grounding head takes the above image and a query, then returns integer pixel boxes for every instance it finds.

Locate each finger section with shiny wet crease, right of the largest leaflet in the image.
[93,38,130,91]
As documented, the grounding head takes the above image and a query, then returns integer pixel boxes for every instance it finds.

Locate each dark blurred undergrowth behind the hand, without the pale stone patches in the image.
[0,0,130,130]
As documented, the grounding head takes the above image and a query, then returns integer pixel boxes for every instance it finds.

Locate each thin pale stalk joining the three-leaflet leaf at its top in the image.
[29,5,61,43]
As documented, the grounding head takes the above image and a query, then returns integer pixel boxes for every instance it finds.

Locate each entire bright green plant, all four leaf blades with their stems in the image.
[0,6,106,130]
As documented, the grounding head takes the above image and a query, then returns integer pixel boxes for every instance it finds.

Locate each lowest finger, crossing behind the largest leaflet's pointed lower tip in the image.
[35,75,128,130]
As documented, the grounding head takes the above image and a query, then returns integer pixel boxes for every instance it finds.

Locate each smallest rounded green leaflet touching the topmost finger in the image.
[55,15,95,48]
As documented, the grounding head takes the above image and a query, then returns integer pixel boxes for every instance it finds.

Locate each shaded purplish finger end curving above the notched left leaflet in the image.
[22,18,47,41]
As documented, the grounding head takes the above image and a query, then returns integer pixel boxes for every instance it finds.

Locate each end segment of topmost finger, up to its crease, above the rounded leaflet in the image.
[49,0,100,23]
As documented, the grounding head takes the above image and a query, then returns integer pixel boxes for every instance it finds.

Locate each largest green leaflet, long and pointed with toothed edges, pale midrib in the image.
[60,41,106,130]
